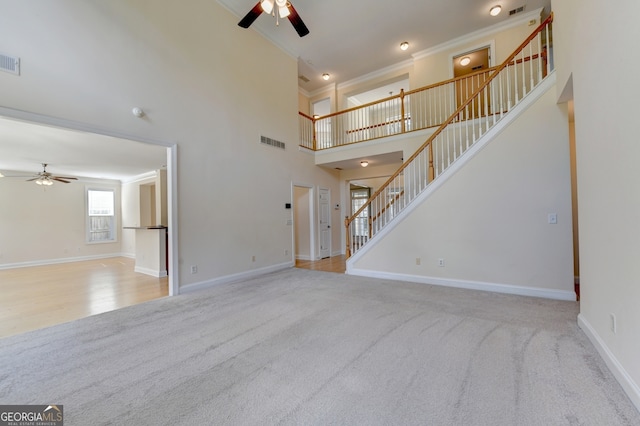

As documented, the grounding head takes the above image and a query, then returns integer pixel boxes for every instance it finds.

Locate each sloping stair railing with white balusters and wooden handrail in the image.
[345,14,553,257]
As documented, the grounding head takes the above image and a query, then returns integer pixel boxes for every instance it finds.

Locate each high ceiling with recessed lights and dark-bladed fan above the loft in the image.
[218,0,551,93]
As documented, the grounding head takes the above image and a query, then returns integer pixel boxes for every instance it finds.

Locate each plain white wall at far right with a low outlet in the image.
[553,0,640,409]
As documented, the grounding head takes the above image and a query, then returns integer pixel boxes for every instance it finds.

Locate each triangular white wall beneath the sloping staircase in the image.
[352,84,575,300]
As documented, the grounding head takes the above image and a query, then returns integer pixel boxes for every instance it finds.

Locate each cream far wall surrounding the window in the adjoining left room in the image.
[0,173,121,268]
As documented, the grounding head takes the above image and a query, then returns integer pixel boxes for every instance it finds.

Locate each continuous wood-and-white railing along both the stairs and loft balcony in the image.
[340,14,553,257]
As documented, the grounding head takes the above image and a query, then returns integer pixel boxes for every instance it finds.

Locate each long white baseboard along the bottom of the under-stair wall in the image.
[346,265,576,302]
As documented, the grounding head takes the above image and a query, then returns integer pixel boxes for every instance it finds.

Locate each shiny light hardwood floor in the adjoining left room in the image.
[0,257,169,338]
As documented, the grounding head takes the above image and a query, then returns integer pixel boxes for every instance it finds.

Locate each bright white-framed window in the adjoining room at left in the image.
[87,189,116,243]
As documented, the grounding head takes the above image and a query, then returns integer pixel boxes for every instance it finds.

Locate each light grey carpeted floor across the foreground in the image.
[0,268,640,426]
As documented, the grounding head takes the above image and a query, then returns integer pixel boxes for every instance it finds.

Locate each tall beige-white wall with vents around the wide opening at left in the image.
[0,0,340,287]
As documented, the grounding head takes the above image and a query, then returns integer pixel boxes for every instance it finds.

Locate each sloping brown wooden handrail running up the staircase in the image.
[345,12,553,235]
